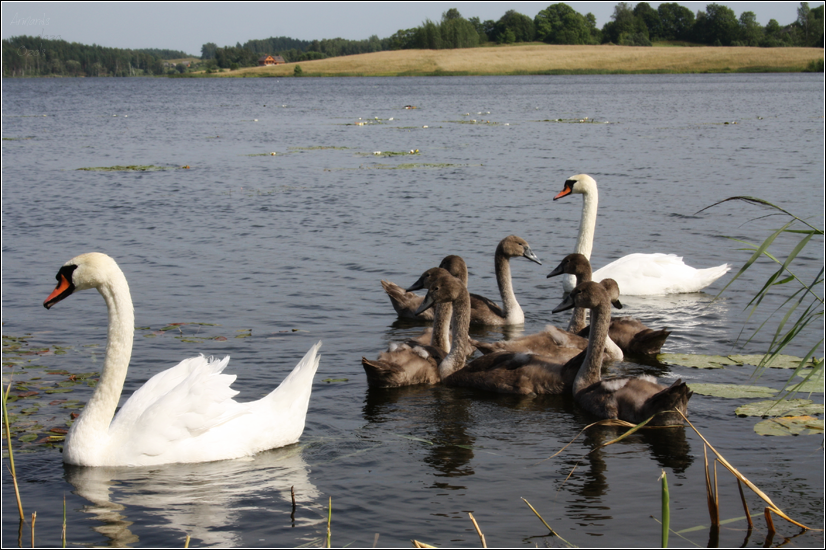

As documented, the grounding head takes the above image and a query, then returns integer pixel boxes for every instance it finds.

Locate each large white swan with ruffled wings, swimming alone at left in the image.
[43,252,321,466]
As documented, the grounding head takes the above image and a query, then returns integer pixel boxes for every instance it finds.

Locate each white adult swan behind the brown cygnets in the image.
[554,174,731,296]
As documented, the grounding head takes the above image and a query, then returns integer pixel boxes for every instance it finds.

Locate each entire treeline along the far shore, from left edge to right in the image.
[2,2,824,76]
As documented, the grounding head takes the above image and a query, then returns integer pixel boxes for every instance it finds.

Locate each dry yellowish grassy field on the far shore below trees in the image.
[196,44,823,77]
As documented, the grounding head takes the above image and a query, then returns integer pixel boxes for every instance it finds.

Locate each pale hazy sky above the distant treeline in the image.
[2,1,823,56]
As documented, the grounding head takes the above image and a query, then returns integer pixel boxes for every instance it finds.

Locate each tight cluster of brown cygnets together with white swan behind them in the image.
[362,174,729,425]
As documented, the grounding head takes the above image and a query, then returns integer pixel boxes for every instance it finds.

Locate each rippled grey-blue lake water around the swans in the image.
[2,74,824,547]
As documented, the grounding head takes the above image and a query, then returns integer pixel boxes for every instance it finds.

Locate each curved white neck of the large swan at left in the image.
[69,269,135,458]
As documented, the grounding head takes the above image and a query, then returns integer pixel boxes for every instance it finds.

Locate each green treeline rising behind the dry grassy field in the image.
[201,2,824,68]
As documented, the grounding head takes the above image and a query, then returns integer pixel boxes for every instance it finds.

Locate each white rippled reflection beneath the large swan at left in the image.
[64,445,326,547]
